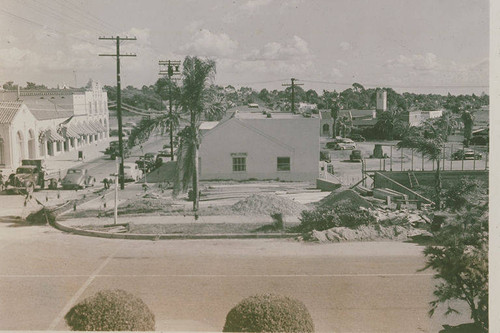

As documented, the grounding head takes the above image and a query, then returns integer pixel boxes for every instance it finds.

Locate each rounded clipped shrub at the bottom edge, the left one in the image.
[65,289,155,331]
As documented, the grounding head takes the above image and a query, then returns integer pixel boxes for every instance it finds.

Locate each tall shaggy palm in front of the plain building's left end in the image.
[177,56,216,218]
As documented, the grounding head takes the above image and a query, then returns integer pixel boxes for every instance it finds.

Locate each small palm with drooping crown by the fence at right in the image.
[398,122,446,209]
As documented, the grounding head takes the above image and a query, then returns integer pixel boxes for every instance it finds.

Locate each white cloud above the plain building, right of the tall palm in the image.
[248,36,312,60]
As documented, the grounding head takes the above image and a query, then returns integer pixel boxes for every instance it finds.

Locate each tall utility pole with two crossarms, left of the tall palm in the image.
[99,36,137,190]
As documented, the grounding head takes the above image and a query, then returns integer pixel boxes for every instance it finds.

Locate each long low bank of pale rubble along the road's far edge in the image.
[299,225,430,243]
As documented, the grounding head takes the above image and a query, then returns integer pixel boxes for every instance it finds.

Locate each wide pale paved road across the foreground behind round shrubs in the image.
[0,221,468,332]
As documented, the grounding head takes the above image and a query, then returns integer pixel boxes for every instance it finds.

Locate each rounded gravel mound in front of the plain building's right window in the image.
[231,194,307,216]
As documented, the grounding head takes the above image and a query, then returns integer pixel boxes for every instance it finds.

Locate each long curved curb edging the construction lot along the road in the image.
[52,221,301,240]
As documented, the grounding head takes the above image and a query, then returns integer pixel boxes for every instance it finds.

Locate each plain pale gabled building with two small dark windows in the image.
[199,111,319,181]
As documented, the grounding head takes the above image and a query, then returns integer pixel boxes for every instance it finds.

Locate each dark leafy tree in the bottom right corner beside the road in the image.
[422,206,488,332]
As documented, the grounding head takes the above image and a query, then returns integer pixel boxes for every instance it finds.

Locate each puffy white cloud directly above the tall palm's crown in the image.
[180,29,238,57]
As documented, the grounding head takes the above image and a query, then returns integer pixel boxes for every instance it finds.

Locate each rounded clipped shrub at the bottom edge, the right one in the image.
[223,294,314,332]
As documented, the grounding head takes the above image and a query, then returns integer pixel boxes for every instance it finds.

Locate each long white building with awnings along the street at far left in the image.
[0,82,109,169]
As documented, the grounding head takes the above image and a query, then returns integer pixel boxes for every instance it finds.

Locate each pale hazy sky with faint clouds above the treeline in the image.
[0,0,489,94]
